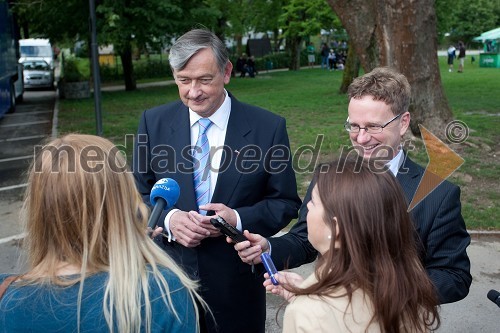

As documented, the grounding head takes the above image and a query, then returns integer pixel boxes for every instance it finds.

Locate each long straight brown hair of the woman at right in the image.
[287,159,439,332]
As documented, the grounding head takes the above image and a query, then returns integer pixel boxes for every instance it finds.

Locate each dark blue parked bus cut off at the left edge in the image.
[0,0,24,117]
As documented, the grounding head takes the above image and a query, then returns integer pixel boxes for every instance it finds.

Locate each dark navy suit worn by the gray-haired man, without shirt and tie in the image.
[133,94,301,333]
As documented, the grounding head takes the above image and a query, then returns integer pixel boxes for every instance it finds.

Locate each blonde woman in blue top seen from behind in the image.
[0,134,204,333]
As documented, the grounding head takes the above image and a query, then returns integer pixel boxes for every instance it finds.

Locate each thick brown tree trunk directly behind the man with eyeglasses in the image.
[327,0,453,138]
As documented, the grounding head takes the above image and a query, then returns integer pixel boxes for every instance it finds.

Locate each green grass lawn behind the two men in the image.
[59,56,500,230]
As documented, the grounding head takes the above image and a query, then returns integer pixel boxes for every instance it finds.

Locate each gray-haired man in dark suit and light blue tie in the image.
[134,29,301,333]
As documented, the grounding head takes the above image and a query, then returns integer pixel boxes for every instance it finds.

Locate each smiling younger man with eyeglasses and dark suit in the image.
[235,67,472,303]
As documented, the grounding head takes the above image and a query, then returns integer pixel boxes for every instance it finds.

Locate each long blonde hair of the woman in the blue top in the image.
[19,134,204,332]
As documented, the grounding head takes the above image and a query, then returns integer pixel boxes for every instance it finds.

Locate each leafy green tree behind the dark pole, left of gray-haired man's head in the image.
[16,0,196,90]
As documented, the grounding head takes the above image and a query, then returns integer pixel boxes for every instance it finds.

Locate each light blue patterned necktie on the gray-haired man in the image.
[193,118,213,215]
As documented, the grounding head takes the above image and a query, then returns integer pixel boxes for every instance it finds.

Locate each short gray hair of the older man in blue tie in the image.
[168,29,229,73]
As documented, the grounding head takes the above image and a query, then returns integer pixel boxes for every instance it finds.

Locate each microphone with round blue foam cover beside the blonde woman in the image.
[148,178,180,229]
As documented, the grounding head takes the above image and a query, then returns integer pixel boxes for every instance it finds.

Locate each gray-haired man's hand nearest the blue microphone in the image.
[170,211,210,247]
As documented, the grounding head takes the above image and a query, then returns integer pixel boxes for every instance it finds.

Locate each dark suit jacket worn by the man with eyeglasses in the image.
[269,157,472,303]
